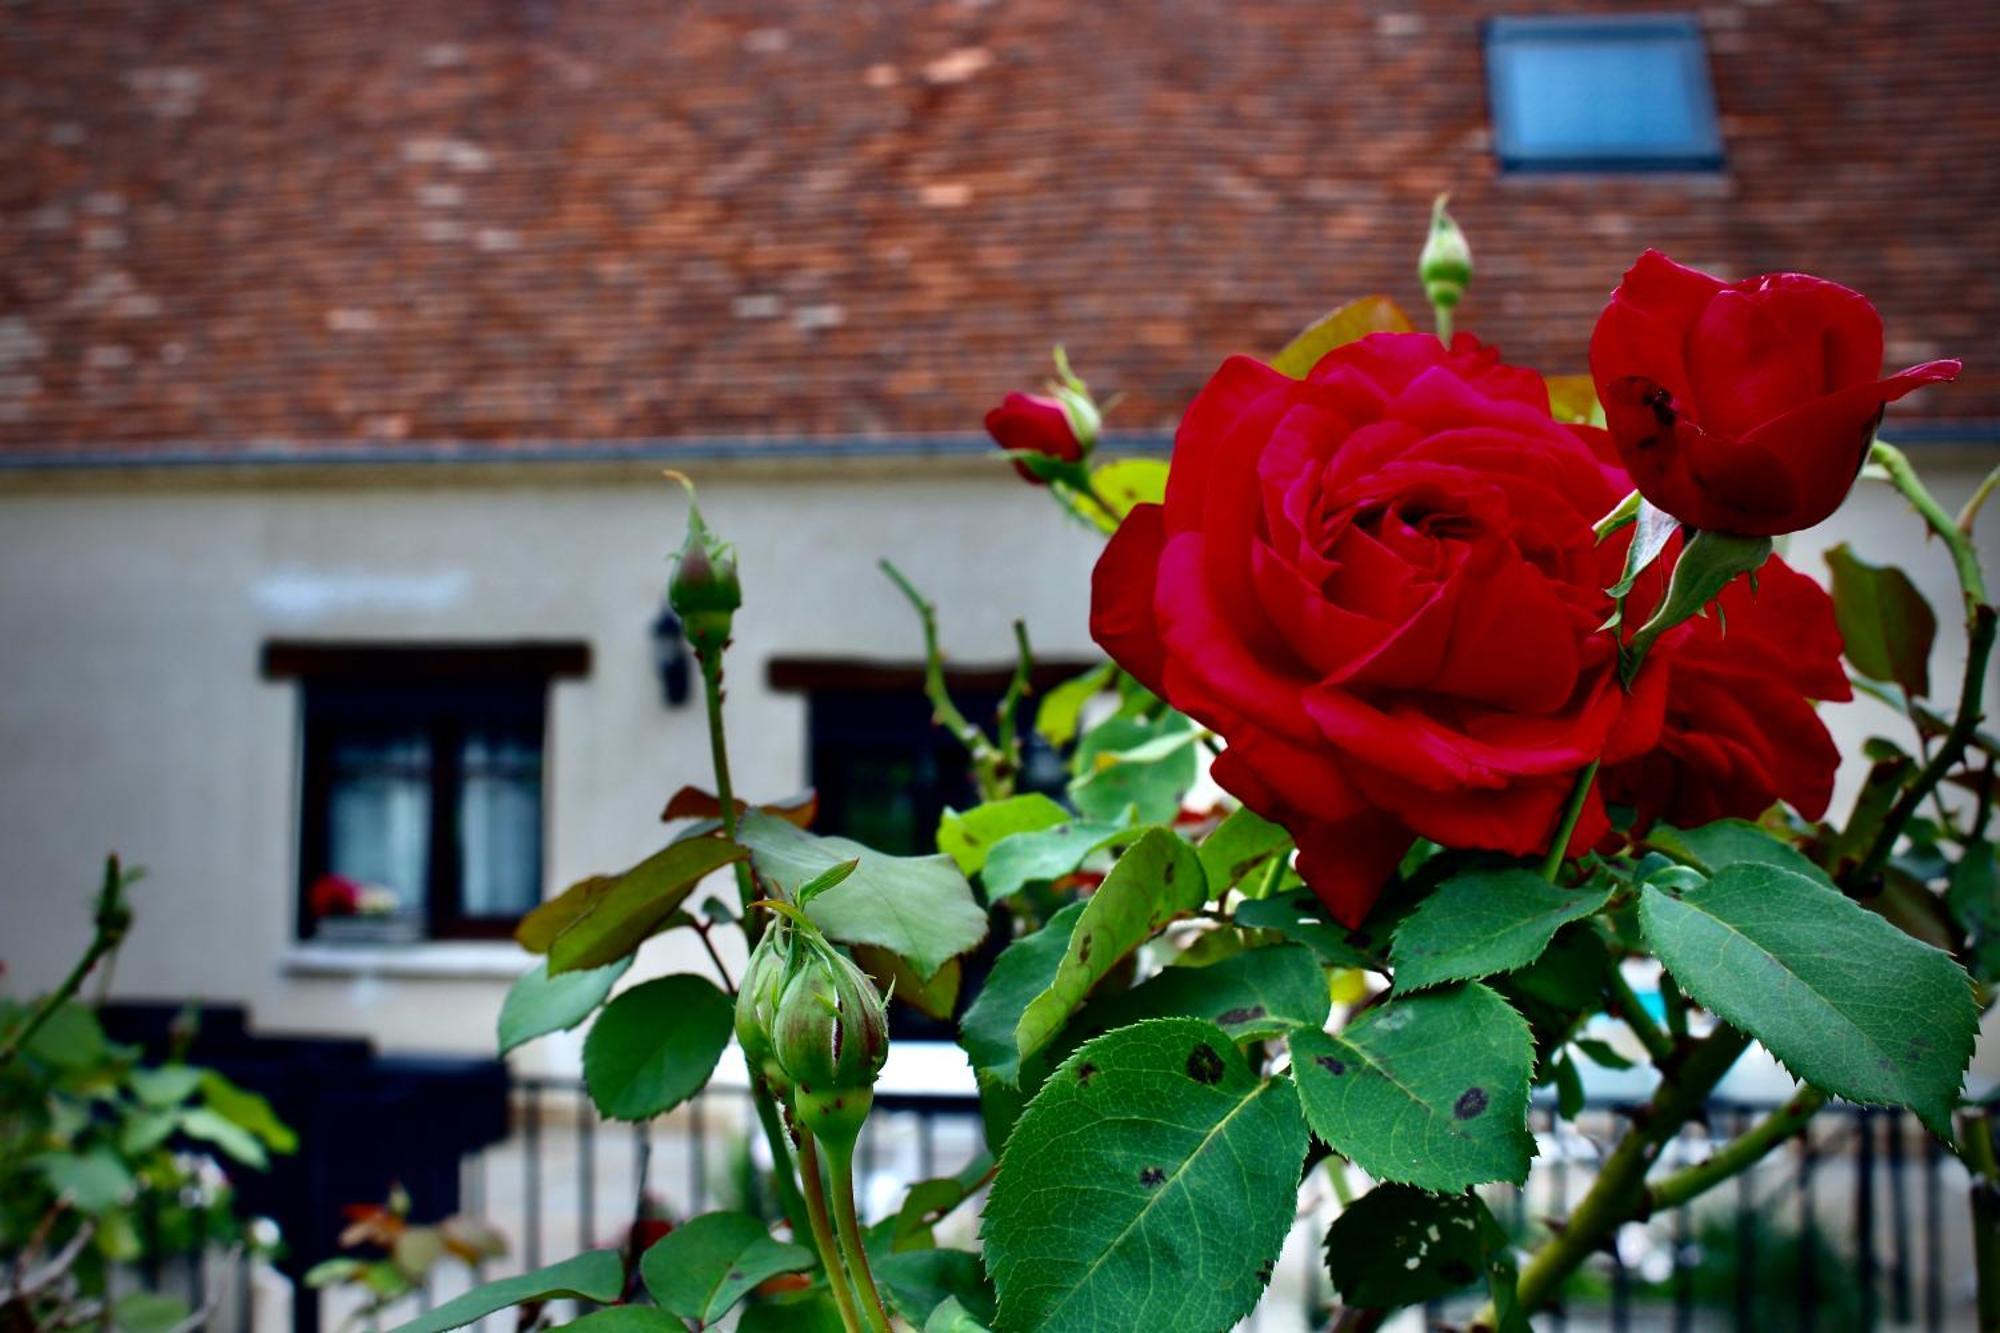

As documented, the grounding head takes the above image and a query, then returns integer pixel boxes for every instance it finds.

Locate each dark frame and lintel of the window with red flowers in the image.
[262,640,590,941]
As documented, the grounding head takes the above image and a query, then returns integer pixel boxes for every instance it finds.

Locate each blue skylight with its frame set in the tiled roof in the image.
[1486,14,1722,172]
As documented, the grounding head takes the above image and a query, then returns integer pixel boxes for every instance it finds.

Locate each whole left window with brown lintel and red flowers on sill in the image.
[266,644,586,943]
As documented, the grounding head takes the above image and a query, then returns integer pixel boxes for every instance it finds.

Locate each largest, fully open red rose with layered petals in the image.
[1090,334,1662,925]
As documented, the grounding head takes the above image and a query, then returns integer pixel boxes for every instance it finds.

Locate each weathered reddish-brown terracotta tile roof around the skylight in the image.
[0,0,2000,454]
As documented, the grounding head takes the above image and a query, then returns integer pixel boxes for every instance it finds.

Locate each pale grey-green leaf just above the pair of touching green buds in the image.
[736,811,986,979]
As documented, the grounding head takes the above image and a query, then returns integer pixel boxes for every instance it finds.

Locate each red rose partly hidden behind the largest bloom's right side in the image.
[1598,542,1852,829]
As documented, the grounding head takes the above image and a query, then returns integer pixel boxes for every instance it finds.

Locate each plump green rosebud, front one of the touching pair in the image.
[772,941,888,1143]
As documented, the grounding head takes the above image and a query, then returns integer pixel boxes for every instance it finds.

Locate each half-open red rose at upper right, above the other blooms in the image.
[1590,250,1958,536]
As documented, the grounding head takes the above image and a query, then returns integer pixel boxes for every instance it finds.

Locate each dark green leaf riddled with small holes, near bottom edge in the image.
[1326,1185,1526,1304]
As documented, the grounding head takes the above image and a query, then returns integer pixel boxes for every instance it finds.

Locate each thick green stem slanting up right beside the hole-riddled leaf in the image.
[1472,1025,1750,1329]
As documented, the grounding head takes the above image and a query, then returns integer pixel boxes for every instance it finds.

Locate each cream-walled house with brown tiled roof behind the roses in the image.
[0,0,2000,1063]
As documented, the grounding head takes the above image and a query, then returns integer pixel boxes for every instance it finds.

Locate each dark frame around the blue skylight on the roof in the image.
[1480,12,1728,176]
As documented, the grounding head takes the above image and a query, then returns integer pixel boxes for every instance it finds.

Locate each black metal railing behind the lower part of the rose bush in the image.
[304,1077,1972,1333]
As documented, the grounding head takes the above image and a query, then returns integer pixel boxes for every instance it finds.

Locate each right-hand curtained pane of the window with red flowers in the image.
[458,733,542,917]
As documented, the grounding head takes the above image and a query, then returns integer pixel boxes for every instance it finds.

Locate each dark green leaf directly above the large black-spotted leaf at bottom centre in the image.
[1070,945,1332,1041]
